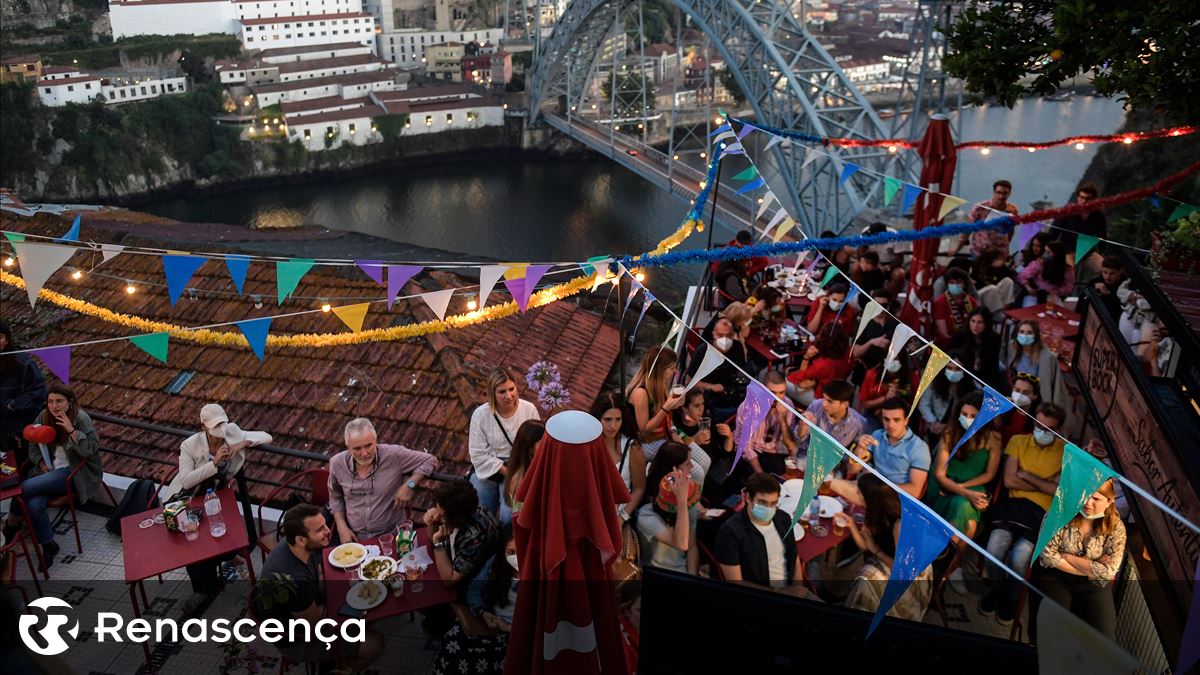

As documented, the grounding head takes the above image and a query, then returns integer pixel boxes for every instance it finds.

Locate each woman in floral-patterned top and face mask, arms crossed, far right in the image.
[1030,479,1126,640]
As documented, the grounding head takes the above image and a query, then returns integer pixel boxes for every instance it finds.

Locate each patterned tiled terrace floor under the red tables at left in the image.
[0,504,437,675]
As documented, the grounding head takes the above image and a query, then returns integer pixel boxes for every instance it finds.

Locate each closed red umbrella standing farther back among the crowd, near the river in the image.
[900,114,959,335]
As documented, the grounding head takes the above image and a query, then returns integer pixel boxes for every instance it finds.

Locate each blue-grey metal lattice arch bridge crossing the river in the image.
[529,0,914,235]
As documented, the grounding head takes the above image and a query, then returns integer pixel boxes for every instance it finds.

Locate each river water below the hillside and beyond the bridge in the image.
[138,96,1124,300]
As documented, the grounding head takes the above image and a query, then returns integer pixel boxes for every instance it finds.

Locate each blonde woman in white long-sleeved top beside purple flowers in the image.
[468,368,541,524]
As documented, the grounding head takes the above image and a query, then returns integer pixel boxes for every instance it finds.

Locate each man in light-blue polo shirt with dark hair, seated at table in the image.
[830,398,931,503]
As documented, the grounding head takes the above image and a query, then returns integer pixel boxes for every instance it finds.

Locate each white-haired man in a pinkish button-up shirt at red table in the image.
[329,417,438,543]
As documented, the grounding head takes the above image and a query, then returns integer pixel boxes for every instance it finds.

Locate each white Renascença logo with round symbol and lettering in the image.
[18,598,367,656]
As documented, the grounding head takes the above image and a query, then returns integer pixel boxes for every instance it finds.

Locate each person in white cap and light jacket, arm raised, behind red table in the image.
[164,404,271,615]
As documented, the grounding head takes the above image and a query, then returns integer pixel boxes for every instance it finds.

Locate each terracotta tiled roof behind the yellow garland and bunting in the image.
[0,214,618,506]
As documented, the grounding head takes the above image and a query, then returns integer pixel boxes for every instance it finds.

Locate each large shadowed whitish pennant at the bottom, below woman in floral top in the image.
[1038,599,1141,675]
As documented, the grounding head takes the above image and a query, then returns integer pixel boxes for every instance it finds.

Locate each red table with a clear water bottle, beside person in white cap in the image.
[121,488,256,671]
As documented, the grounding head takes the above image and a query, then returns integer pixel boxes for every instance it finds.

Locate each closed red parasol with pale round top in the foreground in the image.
[504,411,630,675]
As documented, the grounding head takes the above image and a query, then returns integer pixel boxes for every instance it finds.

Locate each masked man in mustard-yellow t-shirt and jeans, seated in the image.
[979,404,1067,626]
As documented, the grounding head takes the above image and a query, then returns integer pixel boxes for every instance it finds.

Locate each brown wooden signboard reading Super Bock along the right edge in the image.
[1075,305,1200,588]
